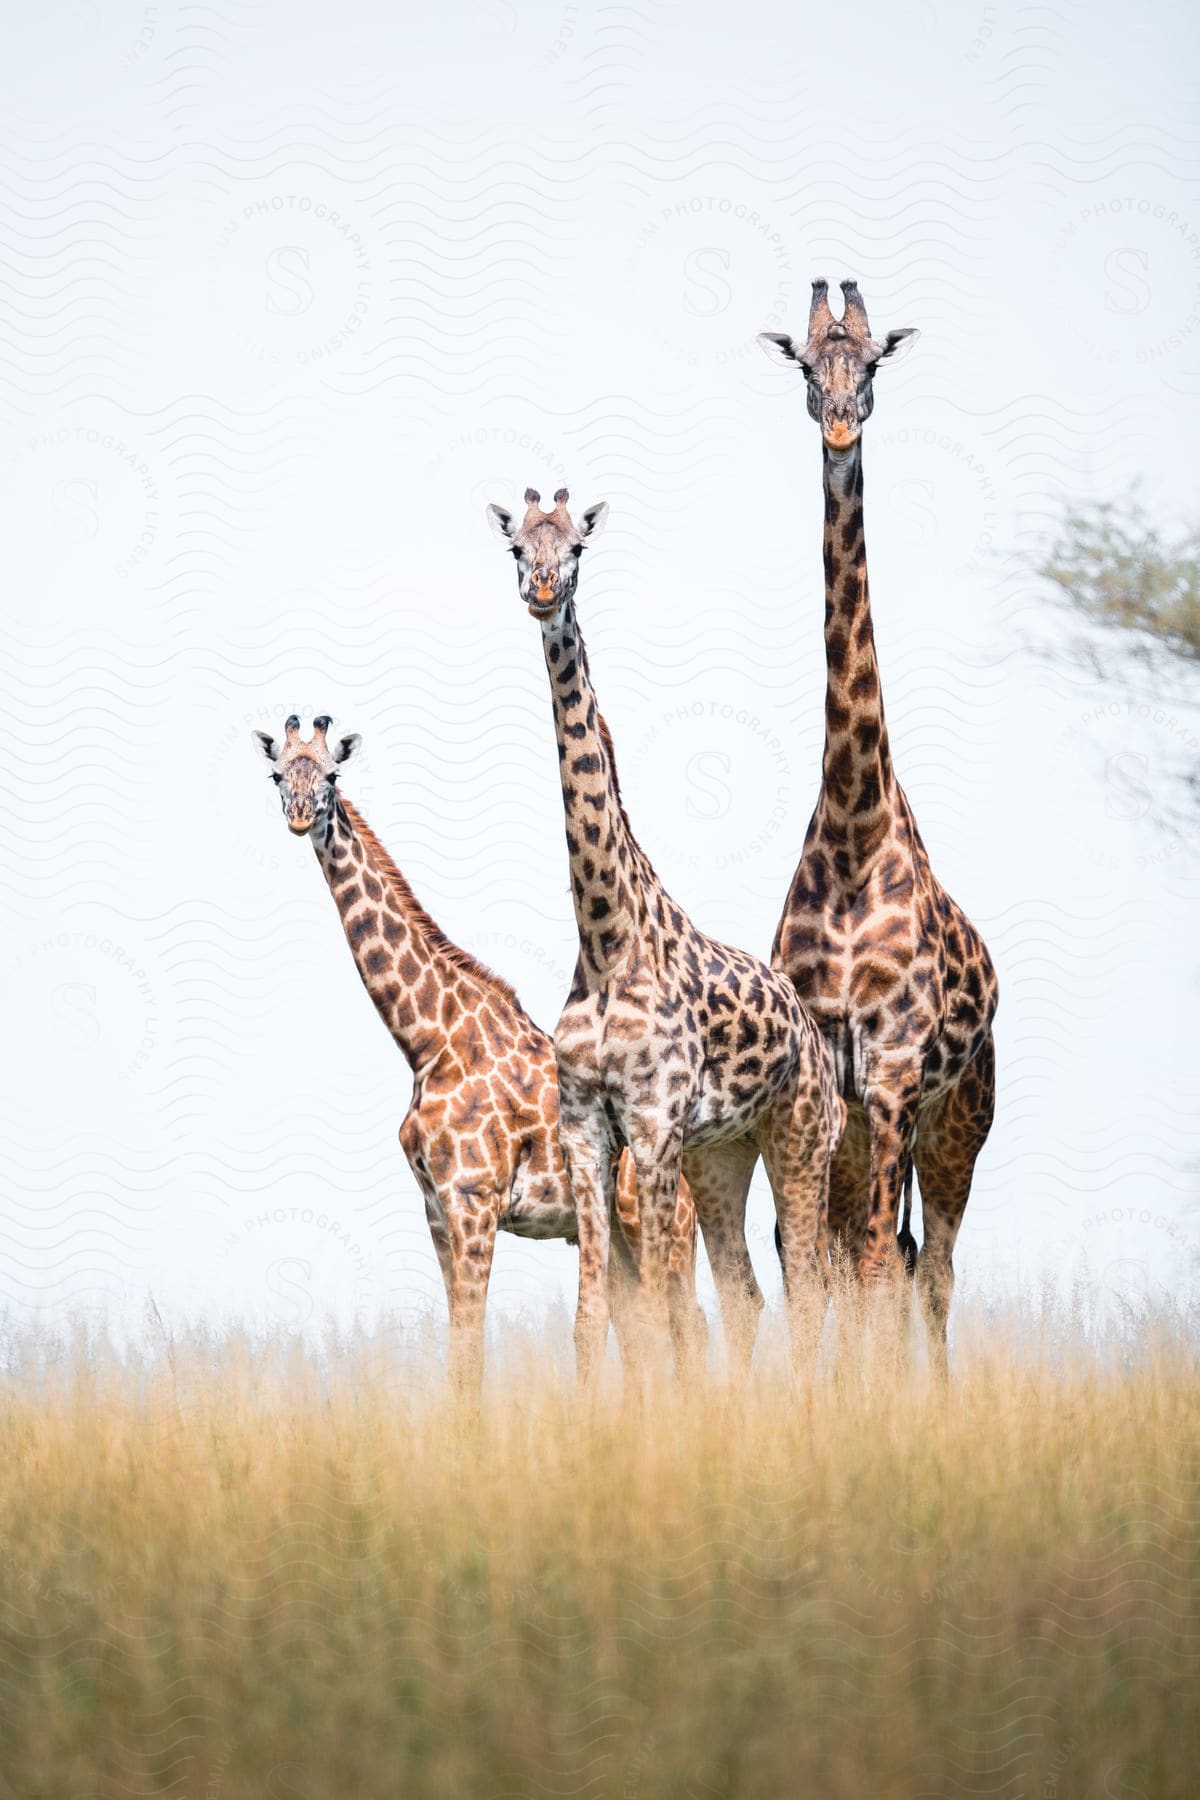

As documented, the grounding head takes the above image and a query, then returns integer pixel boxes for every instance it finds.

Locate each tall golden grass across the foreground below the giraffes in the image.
[0,1301,1200,1800]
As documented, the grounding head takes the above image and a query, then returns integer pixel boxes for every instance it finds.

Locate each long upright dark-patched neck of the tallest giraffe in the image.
[819,443,894,878]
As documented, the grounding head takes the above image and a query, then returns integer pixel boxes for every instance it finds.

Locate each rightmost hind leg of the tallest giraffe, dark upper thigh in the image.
[914,1033,997,1375]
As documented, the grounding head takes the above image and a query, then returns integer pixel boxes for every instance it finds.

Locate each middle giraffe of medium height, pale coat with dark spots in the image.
[488,488,844,1384]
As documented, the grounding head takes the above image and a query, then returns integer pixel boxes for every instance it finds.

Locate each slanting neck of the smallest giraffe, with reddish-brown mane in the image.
[313,794,524,1076]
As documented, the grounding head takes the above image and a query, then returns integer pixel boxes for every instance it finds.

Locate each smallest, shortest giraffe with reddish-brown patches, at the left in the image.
[254,713,705,1390]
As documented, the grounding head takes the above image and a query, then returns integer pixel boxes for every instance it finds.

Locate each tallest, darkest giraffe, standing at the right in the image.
[759,281,997,1372]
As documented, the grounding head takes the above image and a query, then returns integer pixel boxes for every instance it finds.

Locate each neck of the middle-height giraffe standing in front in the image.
[542,601,657,985]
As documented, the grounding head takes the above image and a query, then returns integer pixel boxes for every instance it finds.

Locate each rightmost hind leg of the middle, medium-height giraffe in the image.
[763,1082,833,1372]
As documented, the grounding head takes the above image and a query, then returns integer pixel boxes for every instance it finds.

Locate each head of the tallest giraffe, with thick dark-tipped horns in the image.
[759,279,921,450]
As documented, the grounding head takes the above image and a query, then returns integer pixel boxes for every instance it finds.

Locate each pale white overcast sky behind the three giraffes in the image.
[0,0,1200,1346]
